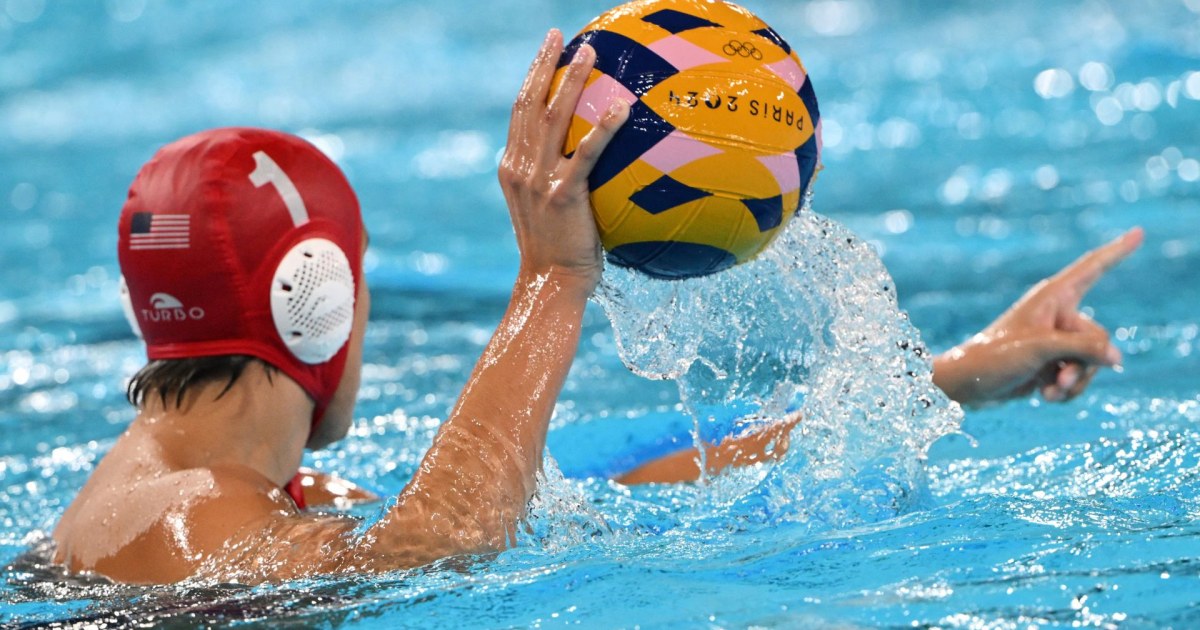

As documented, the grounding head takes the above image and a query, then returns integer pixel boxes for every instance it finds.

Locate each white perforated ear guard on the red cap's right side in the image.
[271,239,354,365]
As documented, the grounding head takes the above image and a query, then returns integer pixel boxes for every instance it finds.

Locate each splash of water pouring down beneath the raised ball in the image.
[598,208,961,526]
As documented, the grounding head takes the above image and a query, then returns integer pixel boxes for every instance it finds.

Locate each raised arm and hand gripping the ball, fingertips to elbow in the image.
[352,31,628,566]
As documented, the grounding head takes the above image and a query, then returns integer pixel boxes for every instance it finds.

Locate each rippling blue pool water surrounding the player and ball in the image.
[0,0,1200,628]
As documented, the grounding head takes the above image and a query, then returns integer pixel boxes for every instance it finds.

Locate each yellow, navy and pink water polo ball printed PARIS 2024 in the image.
[556,0,821,278]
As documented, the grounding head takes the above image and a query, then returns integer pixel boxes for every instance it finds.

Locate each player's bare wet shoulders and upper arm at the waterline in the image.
[54,456,477,584]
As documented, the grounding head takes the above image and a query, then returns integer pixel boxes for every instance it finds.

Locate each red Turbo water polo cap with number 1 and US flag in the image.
[118,128,362,424]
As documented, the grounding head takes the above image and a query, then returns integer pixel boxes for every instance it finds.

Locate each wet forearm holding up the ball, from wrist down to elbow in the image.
[367,267,592,559]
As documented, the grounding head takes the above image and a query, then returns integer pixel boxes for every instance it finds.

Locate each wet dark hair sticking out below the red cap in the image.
[125,354,276,407]
